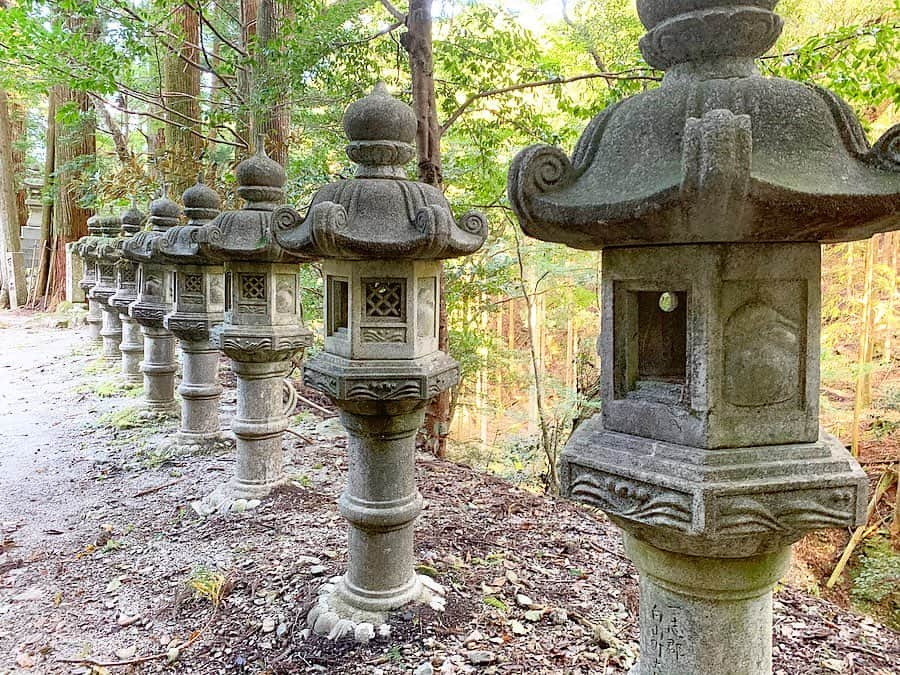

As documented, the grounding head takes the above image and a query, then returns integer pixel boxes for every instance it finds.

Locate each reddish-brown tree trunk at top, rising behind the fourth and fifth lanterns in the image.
[162,2,203,198]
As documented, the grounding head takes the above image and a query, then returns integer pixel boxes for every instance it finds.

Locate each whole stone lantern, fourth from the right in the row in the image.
[155,180,225,452]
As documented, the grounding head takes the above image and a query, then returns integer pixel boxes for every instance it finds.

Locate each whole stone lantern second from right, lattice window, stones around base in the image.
[274,84,487,633]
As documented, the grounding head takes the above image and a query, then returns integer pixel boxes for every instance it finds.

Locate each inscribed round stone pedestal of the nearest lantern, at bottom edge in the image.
[624,533,791,675]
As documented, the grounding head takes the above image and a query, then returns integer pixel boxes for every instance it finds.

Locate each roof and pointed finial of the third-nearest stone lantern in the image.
[196,138,303,263]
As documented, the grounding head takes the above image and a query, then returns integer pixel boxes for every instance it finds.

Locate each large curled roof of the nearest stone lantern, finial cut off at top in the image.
[509,0,900,249]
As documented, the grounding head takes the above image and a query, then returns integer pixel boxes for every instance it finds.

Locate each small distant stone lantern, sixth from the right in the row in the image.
[109,205,144,384]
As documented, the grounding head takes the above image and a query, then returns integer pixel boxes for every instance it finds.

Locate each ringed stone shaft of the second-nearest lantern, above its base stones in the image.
[338,401,425,612]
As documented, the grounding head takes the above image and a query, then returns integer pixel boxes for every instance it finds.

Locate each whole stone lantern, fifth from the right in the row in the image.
[122,196,181,415]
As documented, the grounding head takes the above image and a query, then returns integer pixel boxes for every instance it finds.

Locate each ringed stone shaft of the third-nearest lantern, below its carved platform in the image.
[231,361,291,499]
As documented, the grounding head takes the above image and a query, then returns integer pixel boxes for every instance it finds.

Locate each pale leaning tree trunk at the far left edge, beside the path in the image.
[0,89,28,309]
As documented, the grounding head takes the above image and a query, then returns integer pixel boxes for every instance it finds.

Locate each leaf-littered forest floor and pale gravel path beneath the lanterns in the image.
[0,313,900,675]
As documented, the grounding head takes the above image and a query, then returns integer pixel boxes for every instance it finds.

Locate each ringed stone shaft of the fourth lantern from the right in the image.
[178,340,222,443]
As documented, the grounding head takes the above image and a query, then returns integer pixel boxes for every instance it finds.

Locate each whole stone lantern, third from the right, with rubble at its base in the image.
[194,139,312,509]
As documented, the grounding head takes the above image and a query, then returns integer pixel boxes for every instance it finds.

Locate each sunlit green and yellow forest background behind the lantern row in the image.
[0,0,900,625]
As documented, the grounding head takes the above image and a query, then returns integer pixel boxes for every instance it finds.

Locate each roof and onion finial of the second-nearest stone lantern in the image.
[273,82,487,260]
